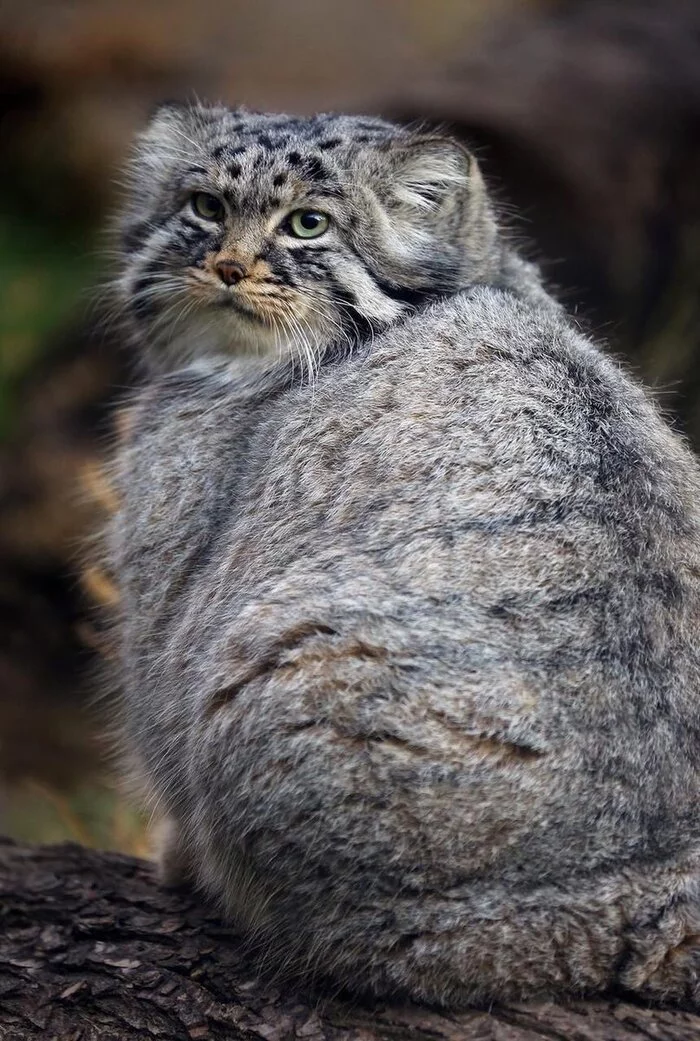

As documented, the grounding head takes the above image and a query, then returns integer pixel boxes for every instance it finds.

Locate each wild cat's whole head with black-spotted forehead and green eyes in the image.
[118,105,495,367]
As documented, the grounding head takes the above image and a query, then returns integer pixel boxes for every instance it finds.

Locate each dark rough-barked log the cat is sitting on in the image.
[0,840,700,1041]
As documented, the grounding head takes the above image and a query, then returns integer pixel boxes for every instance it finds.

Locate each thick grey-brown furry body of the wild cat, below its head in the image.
[110,105,700,1007]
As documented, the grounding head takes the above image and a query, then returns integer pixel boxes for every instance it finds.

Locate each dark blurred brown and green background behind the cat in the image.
[0,0,700,853]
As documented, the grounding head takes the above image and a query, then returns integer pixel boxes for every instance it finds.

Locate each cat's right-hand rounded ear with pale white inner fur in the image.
[392,135,474,217]
